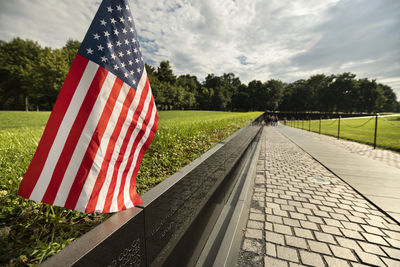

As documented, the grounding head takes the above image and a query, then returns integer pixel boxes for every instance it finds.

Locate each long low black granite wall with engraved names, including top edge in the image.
[43,116,262,266]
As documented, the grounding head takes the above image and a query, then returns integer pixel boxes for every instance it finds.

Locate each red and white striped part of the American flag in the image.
[18,55,158,212]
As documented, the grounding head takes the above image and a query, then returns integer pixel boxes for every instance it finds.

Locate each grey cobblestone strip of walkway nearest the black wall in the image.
[238,127,400,267]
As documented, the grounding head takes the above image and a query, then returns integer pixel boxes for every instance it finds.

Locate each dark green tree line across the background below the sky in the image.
[0,38,400,113]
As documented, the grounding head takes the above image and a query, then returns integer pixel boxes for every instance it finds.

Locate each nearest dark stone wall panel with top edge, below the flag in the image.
[57,208,146,267]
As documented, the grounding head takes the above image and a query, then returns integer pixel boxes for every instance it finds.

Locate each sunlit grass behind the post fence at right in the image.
[288,115,400,152]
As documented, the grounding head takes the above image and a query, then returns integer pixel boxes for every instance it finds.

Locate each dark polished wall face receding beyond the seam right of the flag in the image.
[144,126,260,266]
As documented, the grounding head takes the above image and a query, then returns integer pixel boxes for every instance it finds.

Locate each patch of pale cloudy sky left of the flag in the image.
[0,0,99,47]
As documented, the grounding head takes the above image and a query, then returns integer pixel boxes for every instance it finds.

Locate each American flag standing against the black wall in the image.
[18,0,158,212]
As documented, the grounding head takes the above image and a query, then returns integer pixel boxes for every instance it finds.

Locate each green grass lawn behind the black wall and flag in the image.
[0,111,261,266]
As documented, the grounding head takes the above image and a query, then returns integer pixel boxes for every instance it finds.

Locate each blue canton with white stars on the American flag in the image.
[78,0,144,90]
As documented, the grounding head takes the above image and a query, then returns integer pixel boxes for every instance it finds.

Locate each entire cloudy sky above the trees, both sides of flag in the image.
[0,0,400,100]
